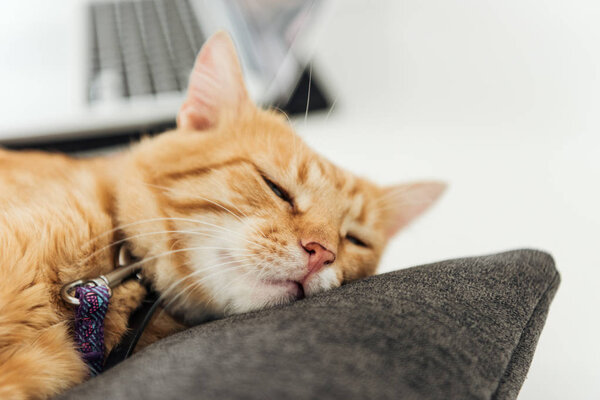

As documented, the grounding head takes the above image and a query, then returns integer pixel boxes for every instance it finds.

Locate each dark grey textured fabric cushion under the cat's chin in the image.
[61,250,560,400]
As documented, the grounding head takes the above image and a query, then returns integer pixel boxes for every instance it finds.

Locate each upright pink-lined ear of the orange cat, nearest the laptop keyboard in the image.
[177,31,250,130]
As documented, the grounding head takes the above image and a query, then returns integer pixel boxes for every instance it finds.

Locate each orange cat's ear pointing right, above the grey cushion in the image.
[379,181,447,238]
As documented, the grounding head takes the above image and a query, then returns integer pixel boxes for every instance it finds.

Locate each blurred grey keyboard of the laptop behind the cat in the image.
[88,0,204,103]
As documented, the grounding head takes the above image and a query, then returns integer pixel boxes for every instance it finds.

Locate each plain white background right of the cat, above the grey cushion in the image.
[295,0,600,400]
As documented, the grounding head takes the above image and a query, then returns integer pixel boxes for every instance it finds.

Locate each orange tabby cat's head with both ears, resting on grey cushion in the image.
[118,32,445,320]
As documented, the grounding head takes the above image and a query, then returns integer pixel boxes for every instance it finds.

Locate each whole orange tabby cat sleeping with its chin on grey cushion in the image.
[0,32,444,399]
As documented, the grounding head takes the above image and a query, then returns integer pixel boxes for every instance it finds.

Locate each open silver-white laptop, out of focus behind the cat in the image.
[0,0,328,146]
